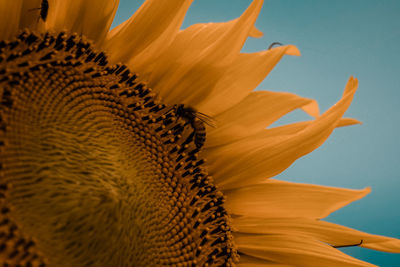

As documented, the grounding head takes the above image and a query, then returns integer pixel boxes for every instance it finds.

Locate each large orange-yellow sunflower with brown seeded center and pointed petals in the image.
[0,0,400,266]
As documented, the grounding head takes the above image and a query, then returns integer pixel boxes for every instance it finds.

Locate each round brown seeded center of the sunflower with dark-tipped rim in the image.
[0,31,237,266]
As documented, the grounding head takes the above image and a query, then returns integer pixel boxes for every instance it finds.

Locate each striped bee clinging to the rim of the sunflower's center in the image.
[173,104,215,149]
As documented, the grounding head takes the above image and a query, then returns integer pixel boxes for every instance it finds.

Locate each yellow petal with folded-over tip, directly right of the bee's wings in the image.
[206,91,318,147]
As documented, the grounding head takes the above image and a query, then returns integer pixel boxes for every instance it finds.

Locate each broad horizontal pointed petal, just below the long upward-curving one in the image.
[224,179,370,219]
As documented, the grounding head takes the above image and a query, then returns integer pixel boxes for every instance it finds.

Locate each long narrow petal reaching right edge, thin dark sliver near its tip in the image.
[232,217,400,253]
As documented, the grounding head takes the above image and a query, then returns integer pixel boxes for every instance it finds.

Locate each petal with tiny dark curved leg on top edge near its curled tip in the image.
[197,45,298,115]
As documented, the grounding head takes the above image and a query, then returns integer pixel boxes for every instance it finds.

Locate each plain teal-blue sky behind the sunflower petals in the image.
[113,0,400,267]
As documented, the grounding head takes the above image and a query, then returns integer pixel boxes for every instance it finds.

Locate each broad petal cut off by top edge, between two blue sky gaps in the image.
[105,0,193,64]
